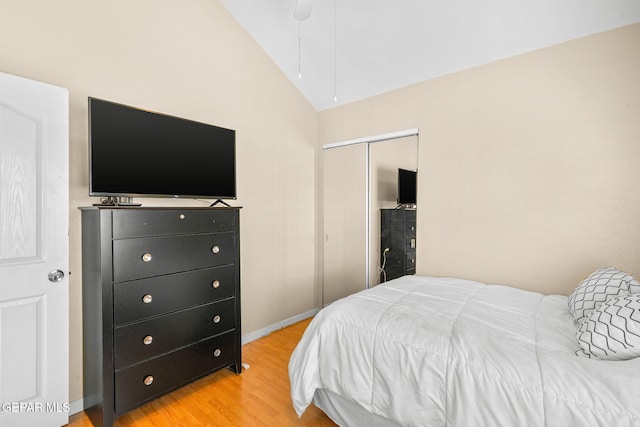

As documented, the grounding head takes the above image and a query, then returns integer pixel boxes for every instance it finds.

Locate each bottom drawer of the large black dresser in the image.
[115,333,235,414]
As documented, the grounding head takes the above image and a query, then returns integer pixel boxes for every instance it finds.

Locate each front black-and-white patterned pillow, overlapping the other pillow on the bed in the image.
[576,295,640,360]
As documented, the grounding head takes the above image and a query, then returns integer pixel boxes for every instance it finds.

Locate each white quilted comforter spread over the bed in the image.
[289,276,640,427]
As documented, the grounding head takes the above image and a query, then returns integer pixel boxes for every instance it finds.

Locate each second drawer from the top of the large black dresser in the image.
[113,233,236,282]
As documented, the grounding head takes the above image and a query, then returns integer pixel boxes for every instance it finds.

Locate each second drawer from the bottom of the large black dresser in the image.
[113,298,236,369]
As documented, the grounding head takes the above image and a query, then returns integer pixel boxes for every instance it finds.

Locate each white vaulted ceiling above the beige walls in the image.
[221,0,640,110]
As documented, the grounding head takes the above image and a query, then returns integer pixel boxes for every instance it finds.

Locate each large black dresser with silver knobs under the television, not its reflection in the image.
[81,207,242,426]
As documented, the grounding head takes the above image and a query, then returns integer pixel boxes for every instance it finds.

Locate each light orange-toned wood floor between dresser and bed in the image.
[69,319,336,427]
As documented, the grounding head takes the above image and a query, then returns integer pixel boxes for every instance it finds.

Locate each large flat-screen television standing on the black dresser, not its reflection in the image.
[89,98,236,199]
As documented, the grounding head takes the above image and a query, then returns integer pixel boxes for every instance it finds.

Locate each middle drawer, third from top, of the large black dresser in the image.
[113,265,236,325]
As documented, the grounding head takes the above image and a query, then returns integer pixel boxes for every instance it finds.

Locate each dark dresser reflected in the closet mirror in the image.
[380,208,416,282]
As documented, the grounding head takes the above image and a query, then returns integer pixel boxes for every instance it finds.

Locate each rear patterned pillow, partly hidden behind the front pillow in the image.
[568,267,640,326]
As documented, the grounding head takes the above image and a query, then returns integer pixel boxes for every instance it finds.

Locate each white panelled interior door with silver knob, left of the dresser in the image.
[0,73,69,426]
